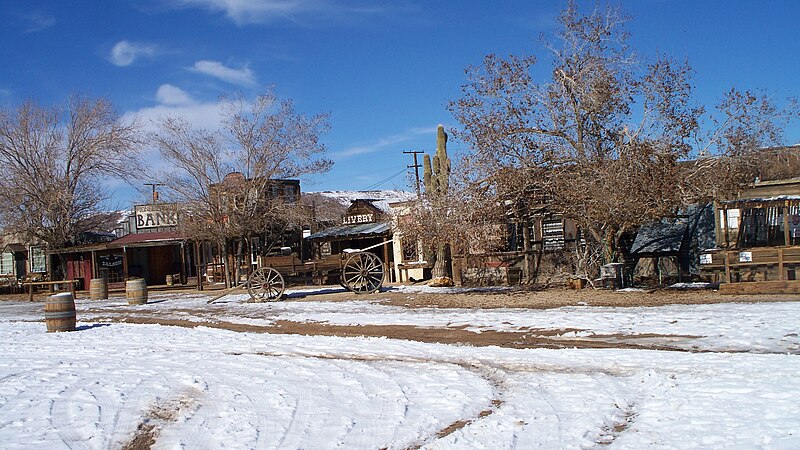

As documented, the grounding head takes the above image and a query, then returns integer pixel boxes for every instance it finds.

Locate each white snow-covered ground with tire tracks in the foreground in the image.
[0,292,800,449]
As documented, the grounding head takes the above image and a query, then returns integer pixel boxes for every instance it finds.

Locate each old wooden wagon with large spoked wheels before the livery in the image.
[247,250,384,302]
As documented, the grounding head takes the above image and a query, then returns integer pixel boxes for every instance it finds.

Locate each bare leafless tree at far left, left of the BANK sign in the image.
[0,95,140,278]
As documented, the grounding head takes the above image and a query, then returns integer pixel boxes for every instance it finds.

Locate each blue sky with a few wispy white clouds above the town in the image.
[0,0,800,206]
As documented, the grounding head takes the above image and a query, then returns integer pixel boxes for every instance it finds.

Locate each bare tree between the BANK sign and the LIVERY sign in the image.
[152,91,332,284]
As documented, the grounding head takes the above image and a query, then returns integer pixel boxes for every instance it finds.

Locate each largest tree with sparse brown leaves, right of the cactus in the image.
[450,2,785,272]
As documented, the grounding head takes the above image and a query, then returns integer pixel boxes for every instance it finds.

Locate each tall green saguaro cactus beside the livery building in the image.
[422,125,450,277]
